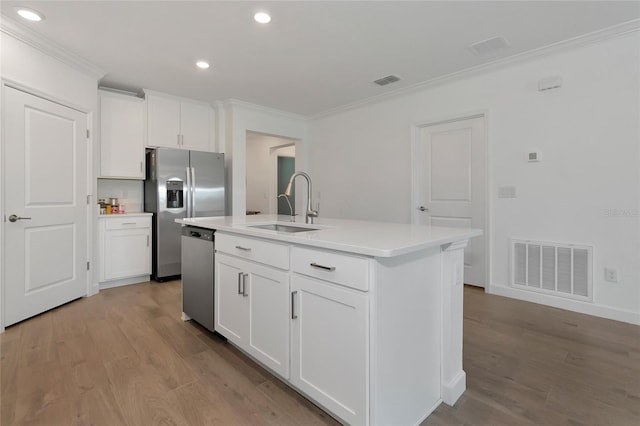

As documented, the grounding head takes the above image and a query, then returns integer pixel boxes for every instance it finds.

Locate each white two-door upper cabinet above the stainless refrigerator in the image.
[145,90,213,151]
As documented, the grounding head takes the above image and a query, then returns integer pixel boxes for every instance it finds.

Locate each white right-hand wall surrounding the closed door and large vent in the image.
[309,32,640,323]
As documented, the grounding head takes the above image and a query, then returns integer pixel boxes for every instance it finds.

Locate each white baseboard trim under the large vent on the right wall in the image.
[486,284,640,325]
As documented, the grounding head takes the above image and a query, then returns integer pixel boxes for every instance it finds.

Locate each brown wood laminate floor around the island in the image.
[0,281,640,426]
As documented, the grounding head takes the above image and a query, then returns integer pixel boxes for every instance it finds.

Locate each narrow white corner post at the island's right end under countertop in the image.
[442,240,468,405]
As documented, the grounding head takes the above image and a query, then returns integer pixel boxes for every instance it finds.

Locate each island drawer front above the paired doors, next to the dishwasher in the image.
[215,233,289,269]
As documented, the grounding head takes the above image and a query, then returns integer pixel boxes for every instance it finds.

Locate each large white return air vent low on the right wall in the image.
[511,239,593,302]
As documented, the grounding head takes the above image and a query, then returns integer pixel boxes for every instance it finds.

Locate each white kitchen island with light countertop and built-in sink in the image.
[176,215,481,425]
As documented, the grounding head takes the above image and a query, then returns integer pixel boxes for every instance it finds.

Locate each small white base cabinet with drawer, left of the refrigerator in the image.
[98,215,151,288]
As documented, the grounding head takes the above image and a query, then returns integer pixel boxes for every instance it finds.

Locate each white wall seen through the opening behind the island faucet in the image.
[247,133,295,214]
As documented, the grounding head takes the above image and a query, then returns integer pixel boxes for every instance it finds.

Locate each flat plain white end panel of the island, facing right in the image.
[370,247,442,425]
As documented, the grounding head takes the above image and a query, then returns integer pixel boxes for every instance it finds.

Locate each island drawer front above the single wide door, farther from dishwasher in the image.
[291,247,370,291]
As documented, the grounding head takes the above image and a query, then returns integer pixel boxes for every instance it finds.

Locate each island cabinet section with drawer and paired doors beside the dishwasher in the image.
[215,234,289,378]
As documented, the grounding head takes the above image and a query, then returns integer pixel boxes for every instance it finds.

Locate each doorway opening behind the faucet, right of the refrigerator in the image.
[246,131,297,215]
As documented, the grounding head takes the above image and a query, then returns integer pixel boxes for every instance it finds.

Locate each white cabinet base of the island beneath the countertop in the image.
[215,232,444,425]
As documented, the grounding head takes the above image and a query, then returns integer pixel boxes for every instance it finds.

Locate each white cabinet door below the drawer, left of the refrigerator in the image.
[102,228,151,281]
